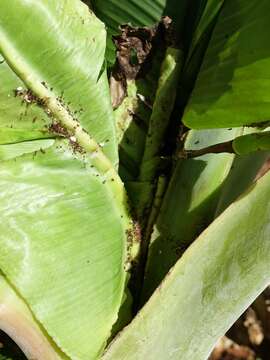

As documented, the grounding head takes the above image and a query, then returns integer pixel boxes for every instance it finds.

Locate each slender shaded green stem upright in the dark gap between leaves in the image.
[130,48,183,313]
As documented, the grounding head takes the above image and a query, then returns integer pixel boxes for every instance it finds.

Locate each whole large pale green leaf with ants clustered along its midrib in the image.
[0,0,132,359]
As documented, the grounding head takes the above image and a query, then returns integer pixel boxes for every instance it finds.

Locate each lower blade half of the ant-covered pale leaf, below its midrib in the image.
[0,140,128,359]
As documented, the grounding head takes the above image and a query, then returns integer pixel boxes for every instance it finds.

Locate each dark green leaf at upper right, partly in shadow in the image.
[183,0,270,128]
